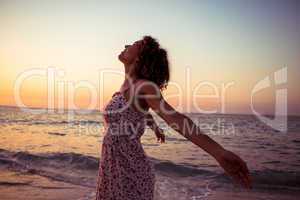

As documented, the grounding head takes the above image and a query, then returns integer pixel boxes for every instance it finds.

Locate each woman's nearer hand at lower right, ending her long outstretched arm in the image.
[217,150,252,189]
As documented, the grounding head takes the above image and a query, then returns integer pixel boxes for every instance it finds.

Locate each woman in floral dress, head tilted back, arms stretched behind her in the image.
[96,36,251,200]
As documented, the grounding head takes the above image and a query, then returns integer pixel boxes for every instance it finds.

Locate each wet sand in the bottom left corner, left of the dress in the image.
[0,170,94,200]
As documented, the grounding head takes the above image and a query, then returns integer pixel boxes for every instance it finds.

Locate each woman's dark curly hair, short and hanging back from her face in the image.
[134,36,170,90]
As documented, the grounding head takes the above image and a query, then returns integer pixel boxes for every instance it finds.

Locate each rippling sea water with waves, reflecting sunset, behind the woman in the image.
[0,107,300,200]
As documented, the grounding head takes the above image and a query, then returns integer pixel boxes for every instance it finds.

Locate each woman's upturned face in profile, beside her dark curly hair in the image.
[119,40,143,65]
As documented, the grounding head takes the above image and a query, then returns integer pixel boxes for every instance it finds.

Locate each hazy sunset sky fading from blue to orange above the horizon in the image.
[0,0,300,115]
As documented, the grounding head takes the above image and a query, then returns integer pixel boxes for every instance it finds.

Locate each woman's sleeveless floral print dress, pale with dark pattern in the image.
[96,91,155,200]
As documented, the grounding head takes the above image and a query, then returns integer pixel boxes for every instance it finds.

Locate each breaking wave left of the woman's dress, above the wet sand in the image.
[0,149,98,188]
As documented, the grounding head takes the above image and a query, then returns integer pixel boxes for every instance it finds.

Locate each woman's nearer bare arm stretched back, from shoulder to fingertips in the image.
[137,80,252,188]
